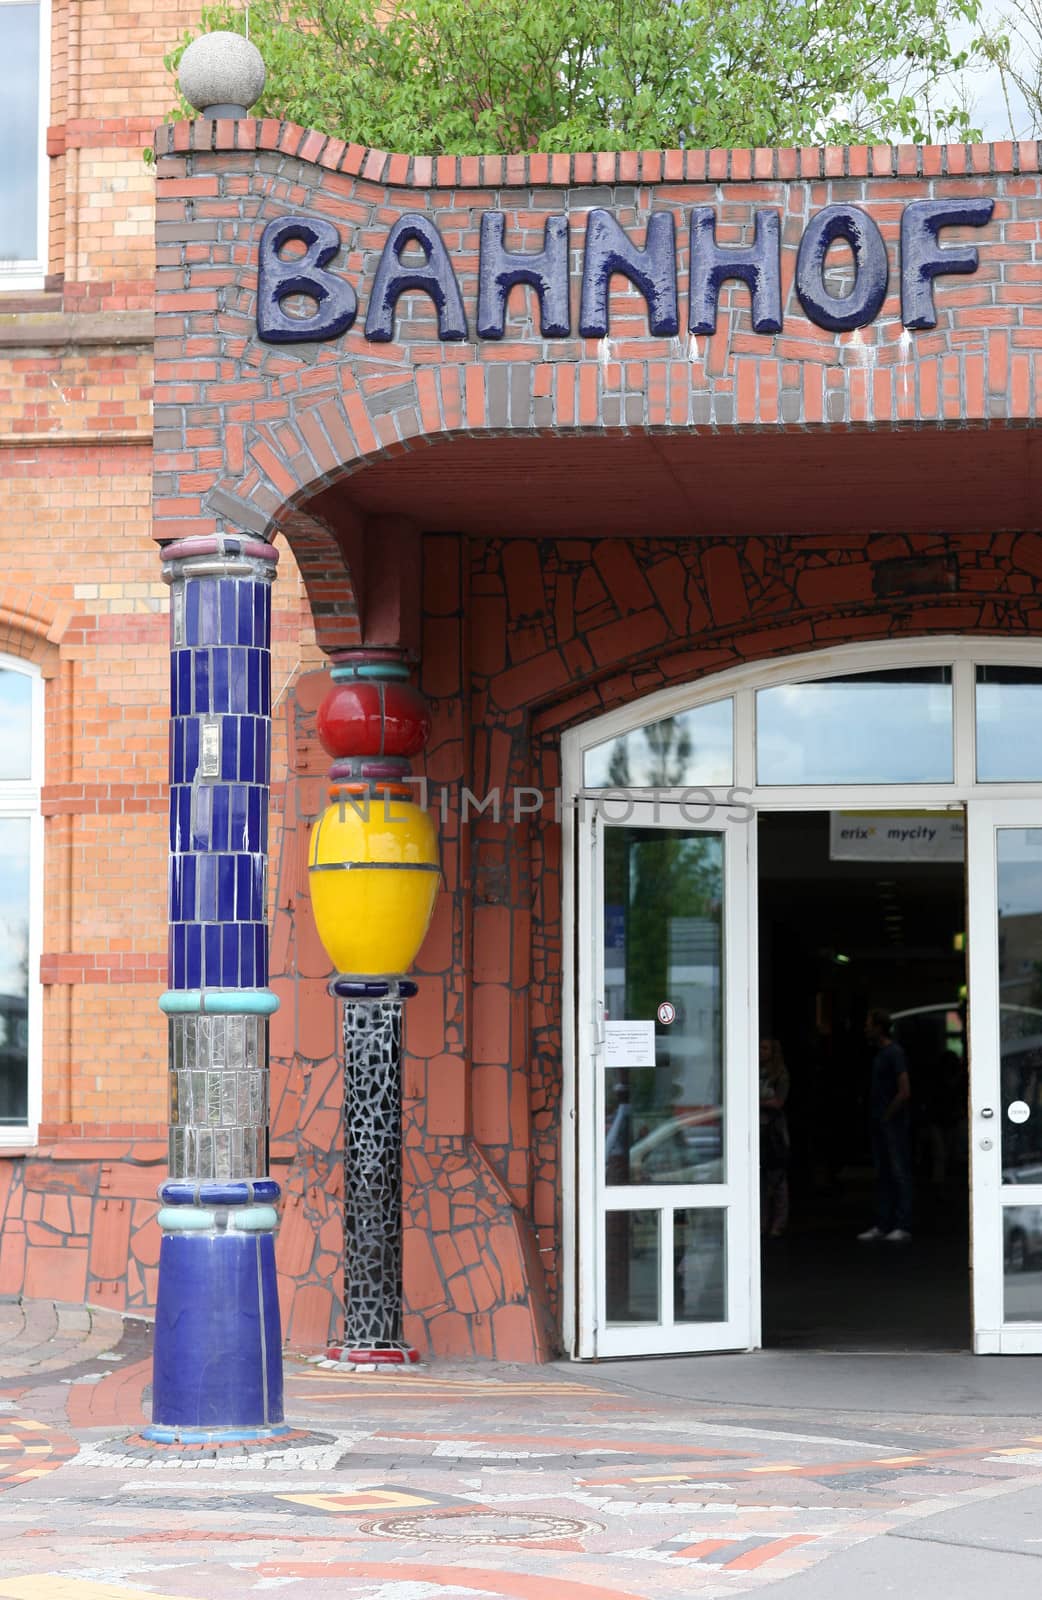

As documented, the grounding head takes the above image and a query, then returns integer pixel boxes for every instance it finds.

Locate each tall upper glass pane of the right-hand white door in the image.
[997,827,1042,1184]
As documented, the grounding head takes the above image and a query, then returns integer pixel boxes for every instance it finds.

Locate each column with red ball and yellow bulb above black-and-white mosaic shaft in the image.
[311,650,439,1366]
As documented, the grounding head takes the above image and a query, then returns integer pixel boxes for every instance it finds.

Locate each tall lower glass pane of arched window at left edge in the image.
[0,816,29,1126]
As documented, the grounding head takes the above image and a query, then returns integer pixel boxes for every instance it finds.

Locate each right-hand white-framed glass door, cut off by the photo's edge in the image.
[968,800,1042,1355]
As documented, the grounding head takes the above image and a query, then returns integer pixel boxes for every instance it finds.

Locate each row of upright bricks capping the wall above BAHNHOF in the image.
[155,118,1040,189]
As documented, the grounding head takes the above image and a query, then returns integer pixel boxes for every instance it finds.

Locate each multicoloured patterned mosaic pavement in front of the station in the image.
[0,1304,1042,1600]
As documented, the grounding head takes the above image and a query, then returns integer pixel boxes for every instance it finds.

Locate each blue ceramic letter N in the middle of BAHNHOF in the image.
[579,206,680,339]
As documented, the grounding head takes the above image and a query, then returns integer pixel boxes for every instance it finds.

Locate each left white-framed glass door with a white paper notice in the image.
[576,798,759,1357]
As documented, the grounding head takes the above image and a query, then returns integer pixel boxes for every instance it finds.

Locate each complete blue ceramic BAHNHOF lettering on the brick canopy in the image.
[256,197,994,344]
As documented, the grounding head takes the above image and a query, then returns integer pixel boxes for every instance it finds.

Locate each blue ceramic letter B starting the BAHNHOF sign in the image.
[256,216,359,344]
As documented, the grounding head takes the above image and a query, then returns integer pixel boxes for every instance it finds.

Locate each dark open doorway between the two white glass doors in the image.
[757,811,972,1350]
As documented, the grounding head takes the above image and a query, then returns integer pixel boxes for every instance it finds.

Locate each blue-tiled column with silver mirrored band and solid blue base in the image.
[146,534,287,1443]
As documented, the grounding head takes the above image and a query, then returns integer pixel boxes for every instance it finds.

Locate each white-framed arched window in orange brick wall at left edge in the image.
[0,656,43,1147]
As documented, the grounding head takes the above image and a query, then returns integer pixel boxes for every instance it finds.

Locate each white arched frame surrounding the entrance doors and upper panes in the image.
[562,635,1042,1358]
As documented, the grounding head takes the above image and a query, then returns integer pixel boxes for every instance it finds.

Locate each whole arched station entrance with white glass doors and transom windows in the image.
[562,640,1042,1357]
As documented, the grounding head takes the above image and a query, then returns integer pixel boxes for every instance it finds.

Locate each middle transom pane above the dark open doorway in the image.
[755,667,954,784]
